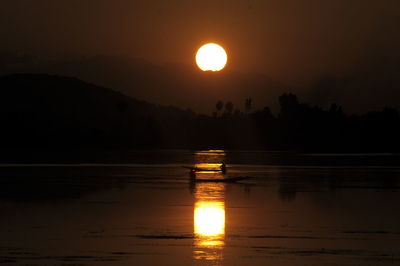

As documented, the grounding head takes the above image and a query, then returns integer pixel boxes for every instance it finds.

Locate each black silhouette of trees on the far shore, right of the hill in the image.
[188,93,400,152]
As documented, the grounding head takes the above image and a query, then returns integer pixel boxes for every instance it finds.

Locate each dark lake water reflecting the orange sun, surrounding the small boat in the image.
[0,151,400,265]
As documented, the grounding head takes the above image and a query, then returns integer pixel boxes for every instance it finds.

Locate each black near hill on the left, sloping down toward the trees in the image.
[0,74,193,148]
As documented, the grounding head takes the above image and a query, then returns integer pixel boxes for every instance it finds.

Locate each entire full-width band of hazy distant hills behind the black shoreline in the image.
[0,55,400,114]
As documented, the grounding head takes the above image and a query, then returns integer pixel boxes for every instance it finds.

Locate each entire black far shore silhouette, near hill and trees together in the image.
[0,75,400,152]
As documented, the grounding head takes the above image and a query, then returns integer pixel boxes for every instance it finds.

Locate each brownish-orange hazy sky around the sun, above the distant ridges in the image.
[0,0,400,84]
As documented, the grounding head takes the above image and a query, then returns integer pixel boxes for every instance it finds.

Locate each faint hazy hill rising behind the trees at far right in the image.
[300,57,400,114]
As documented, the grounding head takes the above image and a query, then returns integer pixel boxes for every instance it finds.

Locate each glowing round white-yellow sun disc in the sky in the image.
[196,43,228,71]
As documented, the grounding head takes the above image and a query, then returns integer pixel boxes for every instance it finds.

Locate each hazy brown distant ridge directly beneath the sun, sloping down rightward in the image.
[0,56,287,114]
